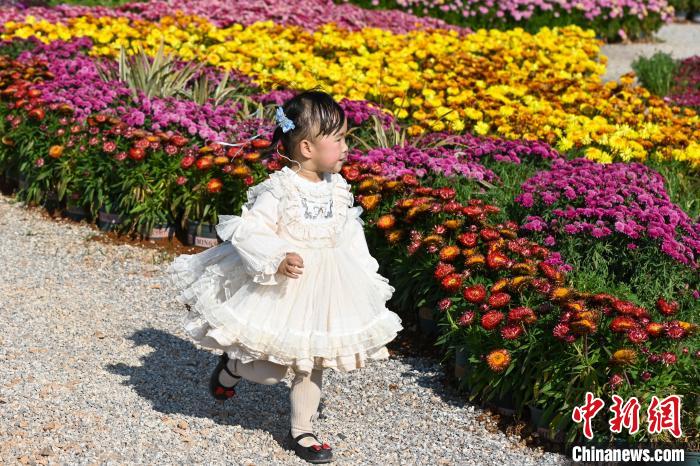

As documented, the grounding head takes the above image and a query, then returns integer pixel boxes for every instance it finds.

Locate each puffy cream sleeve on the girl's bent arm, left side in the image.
[216,191,294,285]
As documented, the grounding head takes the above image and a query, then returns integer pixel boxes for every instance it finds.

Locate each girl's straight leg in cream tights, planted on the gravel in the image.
[289,369,323,447]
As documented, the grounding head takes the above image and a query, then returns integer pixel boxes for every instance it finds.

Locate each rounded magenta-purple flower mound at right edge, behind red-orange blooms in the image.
[516,158,700,269]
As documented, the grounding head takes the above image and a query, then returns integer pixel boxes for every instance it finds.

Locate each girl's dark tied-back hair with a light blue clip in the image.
[261,87,345,165]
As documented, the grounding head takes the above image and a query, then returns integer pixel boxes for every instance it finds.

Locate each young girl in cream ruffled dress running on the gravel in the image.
[168,90,403,463]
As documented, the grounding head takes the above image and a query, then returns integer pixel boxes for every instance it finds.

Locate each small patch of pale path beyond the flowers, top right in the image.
[601,23,700,81]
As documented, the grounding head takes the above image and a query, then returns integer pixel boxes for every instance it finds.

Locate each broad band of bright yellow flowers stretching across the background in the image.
[1,16,700,166]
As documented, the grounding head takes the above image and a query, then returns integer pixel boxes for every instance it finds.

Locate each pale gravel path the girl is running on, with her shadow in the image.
[0,192,570,466]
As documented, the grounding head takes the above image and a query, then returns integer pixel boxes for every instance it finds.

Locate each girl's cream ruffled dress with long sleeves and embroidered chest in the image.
[168,167,403,373]
